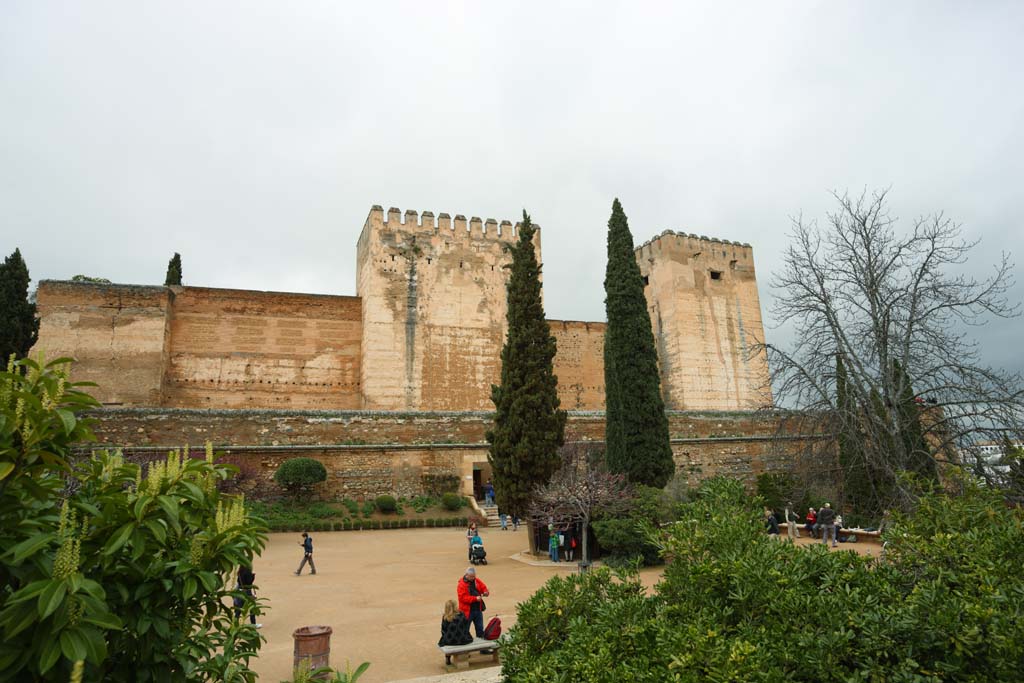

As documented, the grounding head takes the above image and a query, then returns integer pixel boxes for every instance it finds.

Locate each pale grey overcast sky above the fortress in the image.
[0,0,1024,370]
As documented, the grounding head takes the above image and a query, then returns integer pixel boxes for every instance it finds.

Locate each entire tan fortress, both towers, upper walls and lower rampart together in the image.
[33,206,782,496]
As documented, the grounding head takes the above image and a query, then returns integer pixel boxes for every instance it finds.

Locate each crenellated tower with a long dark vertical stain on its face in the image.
[356,206,541,411]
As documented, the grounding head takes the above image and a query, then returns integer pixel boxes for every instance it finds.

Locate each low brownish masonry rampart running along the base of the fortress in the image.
[93,409,800,498]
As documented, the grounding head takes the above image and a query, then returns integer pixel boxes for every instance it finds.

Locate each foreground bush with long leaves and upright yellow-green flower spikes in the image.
[0,359,266,681]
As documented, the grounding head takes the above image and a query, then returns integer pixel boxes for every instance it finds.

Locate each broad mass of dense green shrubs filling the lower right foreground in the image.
[503,479,1024,683]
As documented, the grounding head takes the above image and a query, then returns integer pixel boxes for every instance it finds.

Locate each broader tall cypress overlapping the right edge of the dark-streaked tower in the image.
[487,211,566,516]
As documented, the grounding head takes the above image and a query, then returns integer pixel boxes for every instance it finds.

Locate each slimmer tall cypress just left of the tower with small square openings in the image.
[604,199,676,487]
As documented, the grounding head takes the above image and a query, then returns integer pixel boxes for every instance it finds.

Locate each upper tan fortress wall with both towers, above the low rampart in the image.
[29,206,771,411]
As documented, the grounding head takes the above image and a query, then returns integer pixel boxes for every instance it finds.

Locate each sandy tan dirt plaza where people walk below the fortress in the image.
[253,527,879,683]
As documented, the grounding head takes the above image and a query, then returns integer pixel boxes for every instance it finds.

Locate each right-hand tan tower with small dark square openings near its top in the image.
[636,230,771,411]
